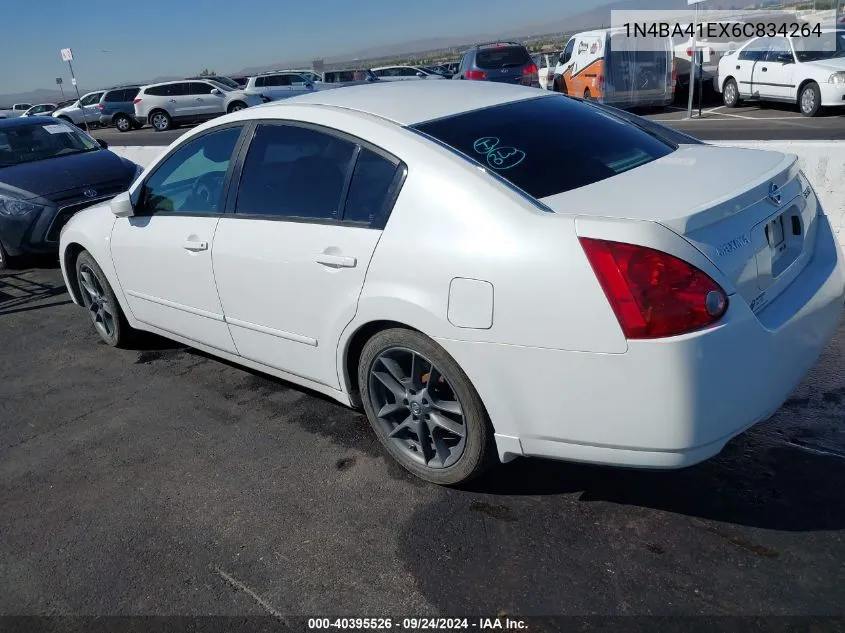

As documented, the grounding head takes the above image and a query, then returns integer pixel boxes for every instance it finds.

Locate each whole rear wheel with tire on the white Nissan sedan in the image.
[358,328,496,486]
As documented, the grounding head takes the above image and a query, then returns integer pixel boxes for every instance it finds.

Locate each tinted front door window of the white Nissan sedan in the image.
[141,127,241,214]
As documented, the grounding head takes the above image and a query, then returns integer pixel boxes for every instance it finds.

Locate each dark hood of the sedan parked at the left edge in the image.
[0,149,136,199]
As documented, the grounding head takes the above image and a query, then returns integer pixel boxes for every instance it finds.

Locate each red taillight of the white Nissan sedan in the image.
[580,237,728,339]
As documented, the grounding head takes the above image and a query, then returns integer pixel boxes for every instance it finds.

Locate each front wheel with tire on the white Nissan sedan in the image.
[75,251,137,347]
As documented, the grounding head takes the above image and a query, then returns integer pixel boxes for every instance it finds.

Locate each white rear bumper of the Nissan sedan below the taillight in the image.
[440,217,845,468]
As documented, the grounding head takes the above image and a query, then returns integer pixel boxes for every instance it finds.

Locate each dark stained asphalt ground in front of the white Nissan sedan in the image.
[0,262,845,616]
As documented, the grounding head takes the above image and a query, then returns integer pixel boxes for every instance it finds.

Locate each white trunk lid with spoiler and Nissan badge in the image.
[541,145,817,311]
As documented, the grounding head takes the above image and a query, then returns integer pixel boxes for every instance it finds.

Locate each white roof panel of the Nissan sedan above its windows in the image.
[268,81,554,125]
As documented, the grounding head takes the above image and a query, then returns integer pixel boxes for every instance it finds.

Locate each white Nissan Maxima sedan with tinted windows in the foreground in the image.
[60,81,845,484]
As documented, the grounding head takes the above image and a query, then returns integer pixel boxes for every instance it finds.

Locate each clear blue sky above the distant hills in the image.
[0,0,592,94]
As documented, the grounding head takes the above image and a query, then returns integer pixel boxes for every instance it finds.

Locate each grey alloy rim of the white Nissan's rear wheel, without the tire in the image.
[369,347,467,469]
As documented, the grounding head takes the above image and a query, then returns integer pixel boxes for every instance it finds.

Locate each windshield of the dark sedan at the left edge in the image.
[0,121,100,167]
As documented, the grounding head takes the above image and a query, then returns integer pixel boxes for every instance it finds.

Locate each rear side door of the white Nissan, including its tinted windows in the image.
[213,123,398,388]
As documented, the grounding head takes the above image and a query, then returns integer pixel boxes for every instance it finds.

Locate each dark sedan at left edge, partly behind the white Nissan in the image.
[0,117,141,269]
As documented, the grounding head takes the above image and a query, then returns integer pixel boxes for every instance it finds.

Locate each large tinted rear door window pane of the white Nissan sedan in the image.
[235,125,355,219]
